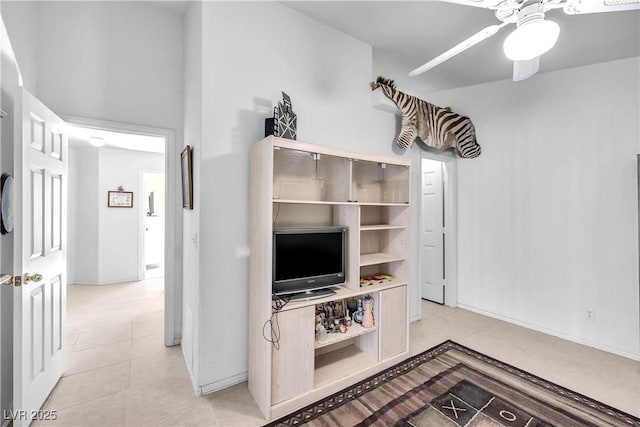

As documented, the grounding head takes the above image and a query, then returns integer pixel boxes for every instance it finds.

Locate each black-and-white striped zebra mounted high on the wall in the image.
[370,77,480,158]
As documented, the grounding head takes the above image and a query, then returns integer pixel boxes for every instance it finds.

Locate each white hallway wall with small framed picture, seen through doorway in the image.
[68,147,164,285]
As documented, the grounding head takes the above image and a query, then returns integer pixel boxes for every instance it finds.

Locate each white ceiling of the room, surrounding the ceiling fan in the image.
[284,1,640,92]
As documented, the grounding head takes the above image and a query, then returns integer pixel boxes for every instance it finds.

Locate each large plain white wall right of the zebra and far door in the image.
[424,57,640,359]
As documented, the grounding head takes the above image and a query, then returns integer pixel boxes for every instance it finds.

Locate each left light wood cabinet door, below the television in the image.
[271,305,315,405]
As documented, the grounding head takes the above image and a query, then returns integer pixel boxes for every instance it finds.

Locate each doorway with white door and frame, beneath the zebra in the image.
[418,152,457,307]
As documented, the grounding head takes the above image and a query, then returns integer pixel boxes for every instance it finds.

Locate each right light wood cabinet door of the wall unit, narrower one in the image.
[378,286,407,361]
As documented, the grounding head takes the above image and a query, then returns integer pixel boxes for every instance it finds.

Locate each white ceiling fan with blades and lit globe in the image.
[409,0,640,81]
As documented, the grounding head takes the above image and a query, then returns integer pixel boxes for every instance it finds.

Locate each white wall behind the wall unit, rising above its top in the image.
[183,2,404,392]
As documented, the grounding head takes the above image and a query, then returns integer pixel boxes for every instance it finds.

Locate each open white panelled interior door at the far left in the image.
[13,89,67,427]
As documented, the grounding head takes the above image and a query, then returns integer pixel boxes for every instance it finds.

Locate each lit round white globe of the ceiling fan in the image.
[502,20,560,61]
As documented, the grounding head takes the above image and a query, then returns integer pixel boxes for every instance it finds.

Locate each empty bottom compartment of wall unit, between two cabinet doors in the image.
[313,345,378,387]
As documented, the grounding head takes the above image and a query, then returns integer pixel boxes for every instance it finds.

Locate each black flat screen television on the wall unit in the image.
[272,226,347,299]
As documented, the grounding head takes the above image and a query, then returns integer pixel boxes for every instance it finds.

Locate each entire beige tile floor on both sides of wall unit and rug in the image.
[34,278,640,426]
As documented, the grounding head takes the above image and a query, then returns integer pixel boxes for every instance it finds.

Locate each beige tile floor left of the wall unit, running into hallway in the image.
[33,278,260,427]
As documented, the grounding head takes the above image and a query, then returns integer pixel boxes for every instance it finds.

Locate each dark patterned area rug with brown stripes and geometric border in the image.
[269,341,640,427]
